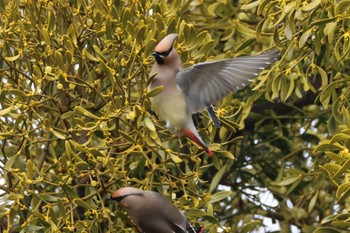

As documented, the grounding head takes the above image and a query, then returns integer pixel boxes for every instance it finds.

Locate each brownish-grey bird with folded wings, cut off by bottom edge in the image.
[111,187,202,233]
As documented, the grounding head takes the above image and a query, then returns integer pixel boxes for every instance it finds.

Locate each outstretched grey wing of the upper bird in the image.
[176,49,279,113]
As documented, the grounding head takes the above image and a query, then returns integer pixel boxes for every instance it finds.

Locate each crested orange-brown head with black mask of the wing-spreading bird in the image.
[152,33,178,65]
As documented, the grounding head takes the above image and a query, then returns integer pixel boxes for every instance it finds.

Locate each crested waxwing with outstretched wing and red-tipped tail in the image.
[148,34,279,156]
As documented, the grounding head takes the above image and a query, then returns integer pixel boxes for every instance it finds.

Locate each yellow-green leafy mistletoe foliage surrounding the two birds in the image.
[0,0,350,232]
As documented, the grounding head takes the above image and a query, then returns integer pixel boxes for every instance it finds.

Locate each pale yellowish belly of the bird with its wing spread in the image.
[151,87,191,135]
